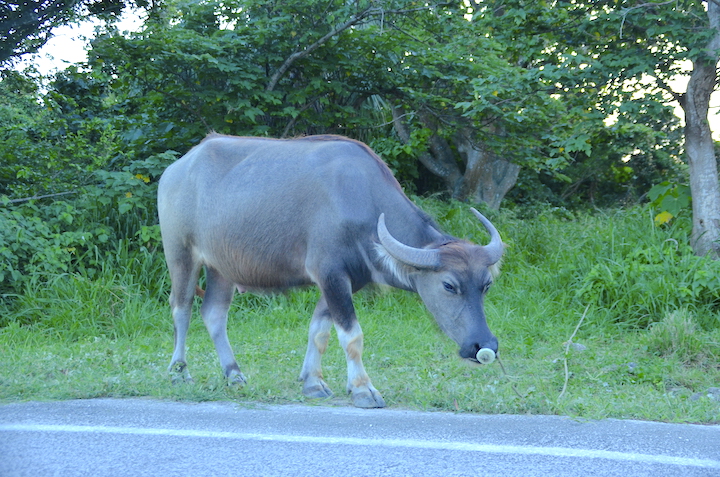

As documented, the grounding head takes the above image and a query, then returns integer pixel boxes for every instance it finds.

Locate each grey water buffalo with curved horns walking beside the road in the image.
[158,134,503,407]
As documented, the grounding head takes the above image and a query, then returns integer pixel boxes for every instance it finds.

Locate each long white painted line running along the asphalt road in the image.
[0,424,720,469]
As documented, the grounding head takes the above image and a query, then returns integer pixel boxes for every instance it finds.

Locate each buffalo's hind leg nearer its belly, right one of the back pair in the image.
[200,267,247,385]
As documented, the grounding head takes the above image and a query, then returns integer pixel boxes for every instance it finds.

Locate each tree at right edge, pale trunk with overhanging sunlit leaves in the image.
[456,0,720,256]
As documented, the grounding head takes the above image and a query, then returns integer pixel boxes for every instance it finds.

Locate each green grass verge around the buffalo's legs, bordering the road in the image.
[0,200,720,423]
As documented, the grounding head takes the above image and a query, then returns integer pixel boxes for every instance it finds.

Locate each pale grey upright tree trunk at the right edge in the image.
[681,1,720,258]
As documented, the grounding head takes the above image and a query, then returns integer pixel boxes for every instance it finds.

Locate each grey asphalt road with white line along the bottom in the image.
[0,399,720,477]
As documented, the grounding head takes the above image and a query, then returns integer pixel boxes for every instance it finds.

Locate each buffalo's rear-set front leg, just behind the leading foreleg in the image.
[300,297,333,398]
